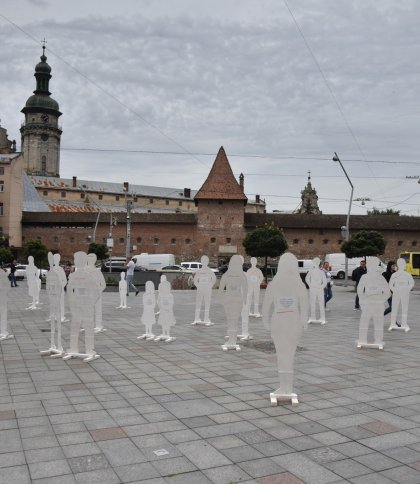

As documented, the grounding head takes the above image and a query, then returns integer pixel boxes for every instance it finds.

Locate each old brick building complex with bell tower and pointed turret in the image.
[0,46,420,265]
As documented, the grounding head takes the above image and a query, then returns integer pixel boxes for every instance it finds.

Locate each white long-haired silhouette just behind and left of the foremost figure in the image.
[219,254,248,351]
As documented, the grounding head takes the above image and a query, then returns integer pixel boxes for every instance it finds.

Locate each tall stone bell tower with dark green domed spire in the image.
[20,42,62,177]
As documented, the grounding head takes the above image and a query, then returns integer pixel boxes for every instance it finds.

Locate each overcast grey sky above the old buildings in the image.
[0,0,420,215]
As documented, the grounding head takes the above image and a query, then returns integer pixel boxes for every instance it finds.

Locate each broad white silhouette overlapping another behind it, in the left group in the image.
[63,251,101,361]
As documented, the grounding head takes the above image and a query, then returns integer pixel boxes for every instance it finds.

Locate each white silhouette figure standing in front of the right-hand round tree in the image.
[357,257,391,350]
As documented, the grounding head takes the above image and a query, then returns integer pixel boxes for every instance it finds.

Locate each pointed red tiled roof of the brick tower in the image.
[194,146,248,203]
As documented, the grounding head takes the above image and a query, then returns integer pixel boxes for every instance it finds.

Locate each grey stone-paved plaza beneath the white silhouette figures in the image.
[0,283,420,484]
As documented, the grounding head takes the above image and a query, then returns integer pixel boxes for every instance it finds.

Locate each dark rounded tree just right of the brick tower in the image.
[242,222,289,278]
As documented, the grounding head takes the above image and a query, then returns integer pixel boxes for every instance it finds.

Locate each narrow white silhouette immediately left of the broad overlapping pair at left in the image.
[40,252,64,357]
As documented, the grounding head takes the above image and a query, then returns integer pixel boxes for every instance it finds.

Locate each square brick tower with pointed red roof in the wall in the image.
[194,146,248,264]
